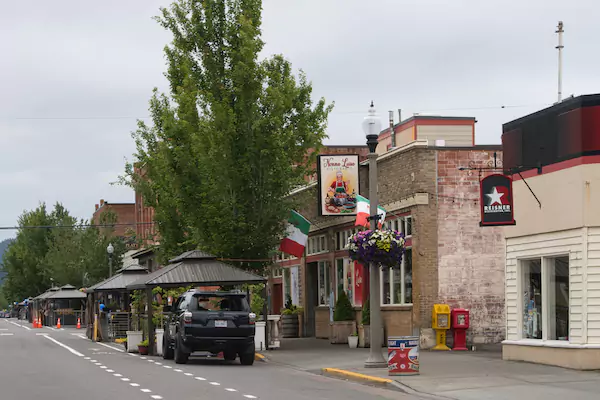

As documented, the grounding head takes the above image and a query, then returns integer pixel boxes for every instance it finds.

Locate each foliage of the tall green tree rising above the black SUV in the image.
[121,0,333,269]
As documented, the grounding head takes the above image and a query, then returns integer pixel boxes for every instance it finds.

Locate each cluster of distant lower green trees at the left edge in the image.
[2,203,125,301]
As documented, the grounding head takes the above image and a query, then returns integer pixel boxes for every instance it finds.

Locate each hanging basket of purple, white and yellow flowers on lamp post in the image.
[348,230,404,268]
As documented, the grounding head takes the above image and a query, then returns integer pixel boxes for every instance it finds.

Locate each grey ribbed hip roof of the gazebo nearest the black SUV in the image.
[127,256,266,290]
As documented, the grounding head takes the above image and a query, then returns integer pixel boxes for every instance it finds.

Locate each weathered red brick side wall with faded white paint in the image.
[437,147,505,343]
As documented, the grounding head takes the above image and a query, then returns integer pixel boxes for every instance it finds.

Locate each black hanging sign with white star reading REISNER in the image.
[479,174,516,226]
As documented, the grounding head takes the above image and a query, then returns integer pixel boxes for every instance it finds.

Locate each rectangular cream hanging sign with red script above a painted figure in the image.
[317,154,359,216]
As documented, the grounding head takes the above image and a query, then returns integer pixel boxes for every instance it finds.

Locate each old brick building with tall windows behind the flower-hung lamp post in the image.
[271,118,504,343]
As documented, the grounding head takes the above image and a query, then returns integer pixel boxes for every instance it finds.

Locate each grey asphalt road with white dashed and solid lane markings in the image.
[0,319,424,400]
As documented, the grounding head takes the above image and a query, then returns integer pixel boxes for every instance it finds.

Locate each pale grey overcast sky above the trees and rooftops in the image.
[0,0,600,240]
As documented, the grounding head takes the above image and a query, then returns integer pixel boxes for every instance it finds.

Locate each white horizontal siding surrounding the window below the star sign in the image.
[506,229,584,343]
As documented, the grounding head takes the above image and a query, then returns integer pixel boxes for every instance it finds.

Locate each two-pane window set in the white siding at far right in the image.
[521,256,569,340]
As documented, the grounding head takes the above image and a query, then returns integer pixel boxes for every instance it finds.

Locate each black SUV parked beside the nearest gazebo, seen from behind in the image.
[162,290,256,365]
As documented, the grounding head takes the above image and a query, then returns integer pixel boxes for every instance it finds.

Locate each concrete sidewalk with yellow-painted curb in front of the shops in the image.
[263,339,600,400]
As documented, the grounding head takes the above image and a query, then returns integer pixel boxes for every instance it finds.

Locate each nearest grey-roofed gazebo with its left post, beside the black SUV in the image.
[127,250,267,354]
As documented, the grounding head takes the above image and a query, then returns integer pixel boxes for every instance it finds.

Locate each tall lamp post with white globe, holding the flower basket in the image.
[363,102,387,368]
